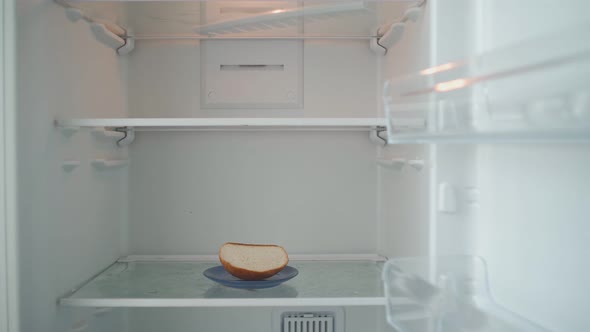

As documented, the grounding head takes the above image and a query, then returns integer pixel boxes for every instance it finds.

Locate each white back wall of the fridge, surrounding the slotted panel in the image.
[129,41,377,254]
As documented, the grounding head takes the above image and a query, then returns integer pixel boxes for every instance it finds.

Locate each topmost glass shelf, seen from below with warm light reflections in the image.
[55,0,421,40]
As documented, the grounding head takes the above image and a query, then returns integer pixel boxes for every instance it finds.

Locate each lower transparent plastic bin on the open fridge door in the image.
[383,256,548,332]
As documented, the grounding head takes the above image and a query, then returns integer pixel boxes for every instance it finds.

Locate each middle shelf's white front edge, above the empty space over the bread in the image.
[56,118,386,131]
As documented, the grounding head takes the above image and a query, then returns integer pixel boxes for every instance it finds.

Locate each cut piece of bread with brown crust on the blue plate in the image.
[219,242,289,280]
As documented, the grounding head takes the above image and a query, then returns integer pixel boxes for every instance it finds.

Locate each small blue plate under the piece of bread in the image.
[203,265,299,289]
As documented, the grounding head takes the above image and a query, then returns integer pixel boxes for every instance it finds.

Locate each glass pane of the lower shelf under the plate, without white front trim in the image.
[62,261,383,306]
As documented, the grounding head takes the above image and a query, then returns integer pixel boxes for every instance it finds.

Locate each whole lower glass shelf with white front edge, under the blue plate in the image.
[59,256,385,307]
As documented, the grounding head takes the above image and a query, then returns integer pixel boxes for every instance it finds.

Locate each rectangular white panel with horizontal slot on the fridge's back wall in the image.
[201,40,303,109]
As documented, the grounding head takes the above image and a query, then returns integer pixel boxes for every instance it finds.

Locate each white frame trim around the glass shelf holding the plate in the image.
[58,254,387,308]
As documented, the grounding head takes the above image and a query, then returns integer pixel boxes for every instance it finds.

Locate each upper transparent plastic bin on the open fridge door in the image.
[384,25,590,144]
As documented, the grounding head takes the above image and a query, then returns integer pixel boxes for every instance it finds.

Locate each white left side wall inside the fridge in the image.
[17,0,127,332]
